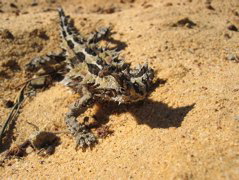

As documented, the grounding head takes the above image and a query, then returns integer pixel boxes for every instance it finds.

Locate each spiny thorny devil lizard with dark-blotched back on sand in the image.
[26,8,154,148]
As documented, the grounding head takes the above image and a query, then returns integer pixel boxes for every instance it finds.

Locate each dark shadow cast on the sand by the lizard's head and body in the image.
[95,80,195,128]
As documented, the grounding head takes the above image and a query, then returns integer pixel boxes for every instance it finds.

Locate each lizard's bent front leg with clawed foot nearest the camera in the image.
[65,87,97,148]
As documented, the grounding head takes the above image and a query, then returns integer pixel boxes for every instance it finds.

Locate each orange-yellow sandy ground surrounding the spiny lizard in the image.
[0,0,239,179]
